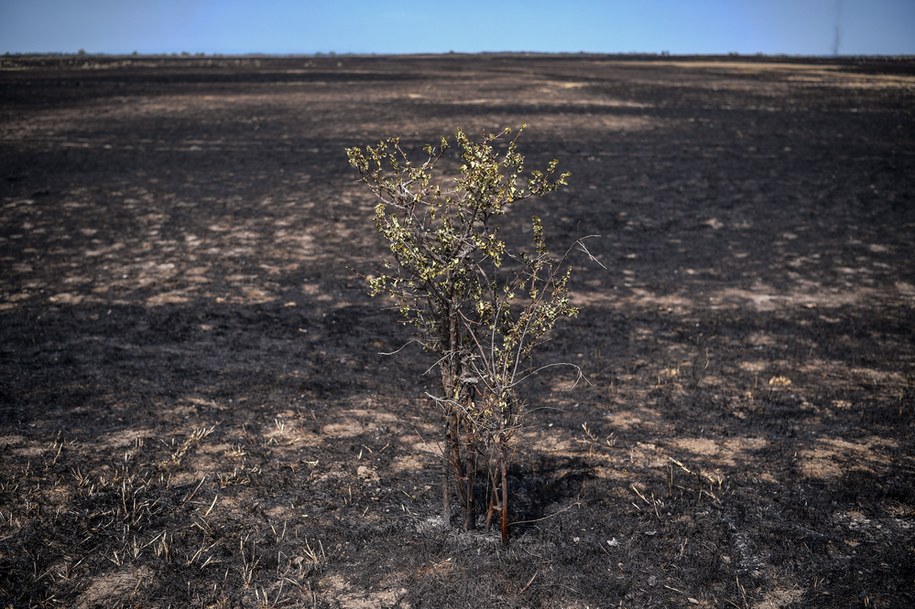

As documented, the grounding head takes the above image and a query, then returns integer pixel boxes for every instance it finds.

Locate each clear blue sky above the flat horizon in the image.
[0,0,915,55]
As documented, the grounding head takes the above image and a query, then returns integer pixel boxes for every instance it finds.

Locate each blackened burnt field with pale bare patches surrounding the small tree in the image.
[0,55,915,609]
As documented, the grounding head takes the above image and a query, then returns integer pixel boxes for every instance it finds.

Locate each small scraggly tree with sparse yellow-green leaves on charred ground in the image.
[346,125,577,542]
